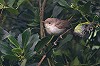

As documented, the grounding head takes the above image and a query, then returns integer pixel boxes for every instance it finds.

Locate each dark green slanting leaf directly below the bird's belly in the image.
[35,36,52,52]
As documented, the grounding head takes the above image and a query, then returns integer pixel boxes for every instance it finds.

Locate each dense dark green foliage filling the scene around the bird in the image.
[0,0,100,66]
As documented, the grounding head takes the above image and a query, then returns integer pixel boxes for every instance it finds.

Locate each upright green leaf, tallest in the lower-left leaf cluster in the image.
[22,28,31,48]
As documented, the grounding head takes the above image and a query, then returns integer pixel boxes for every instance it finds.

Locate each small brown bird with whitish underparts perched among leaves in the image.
[43,18,69,35]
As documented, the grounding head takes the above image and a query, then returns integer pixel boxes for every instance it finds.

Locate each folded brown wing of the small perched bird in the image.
[55,19,69,29]
